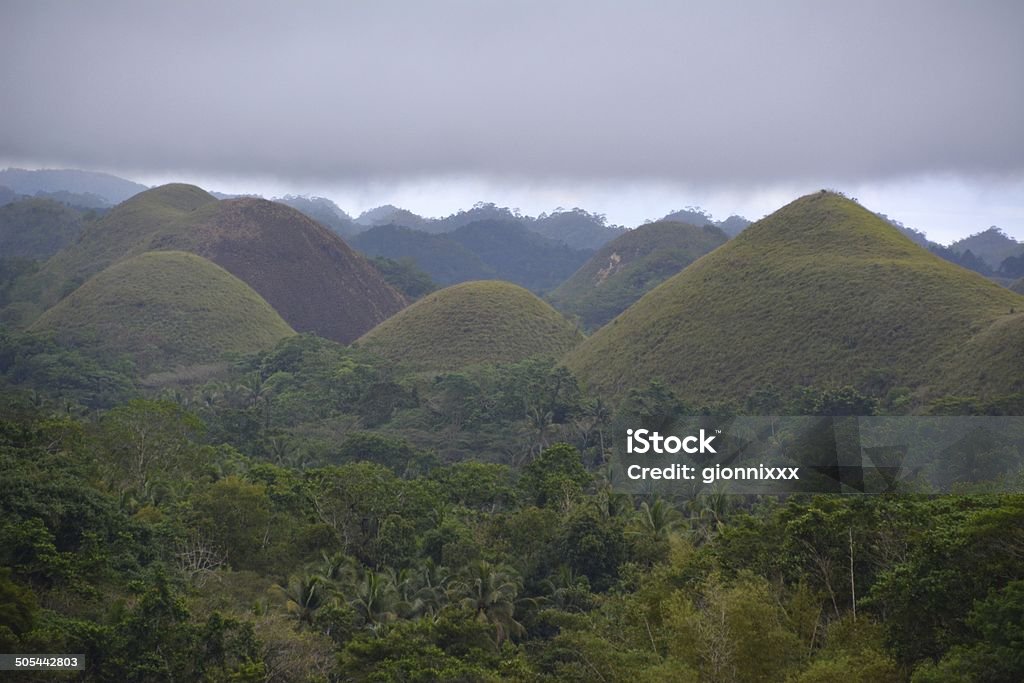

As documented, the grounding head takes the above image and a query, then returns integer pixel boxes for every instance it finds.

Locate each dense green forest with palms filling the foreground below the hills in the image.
[0,332,1024,683]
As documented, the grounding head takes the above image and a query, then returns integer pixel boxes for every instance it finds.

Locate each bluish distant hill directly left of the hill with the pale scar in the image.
[449,220,592,293]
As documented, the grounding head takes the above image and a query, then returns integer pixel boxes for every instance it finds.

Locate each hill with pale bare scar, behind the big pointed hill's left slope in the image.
[548,221,728,330]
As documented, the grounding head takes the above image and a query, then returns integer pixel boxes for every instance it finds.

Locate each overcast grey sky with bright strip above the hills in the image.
[0,0,1024,242]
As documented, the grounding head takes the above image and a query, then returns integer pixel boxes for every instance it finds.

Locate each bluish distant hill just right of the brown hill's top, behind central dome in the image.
[348,225,497,286]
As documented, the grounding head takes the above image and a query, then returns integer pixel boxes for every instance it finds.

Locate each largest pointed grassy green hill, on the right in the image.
[566,191,1024,402]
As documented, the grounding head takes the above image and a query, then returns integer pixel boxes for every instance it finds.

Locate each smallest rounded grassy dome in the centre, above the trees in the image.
[359,281,583,371]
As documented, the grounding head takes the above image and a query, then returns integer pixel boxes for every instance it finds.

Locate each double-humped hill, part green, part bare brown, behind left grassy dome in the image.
[22,184,406,343]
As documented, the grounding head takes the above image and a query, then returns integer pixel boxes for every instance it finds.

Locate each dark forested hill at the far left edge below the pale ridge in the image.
[0,198,85,260]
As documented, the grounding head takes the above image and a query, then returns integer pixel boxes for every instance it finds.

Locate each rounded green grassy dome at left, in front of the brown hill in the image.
[31,251,295,373]
